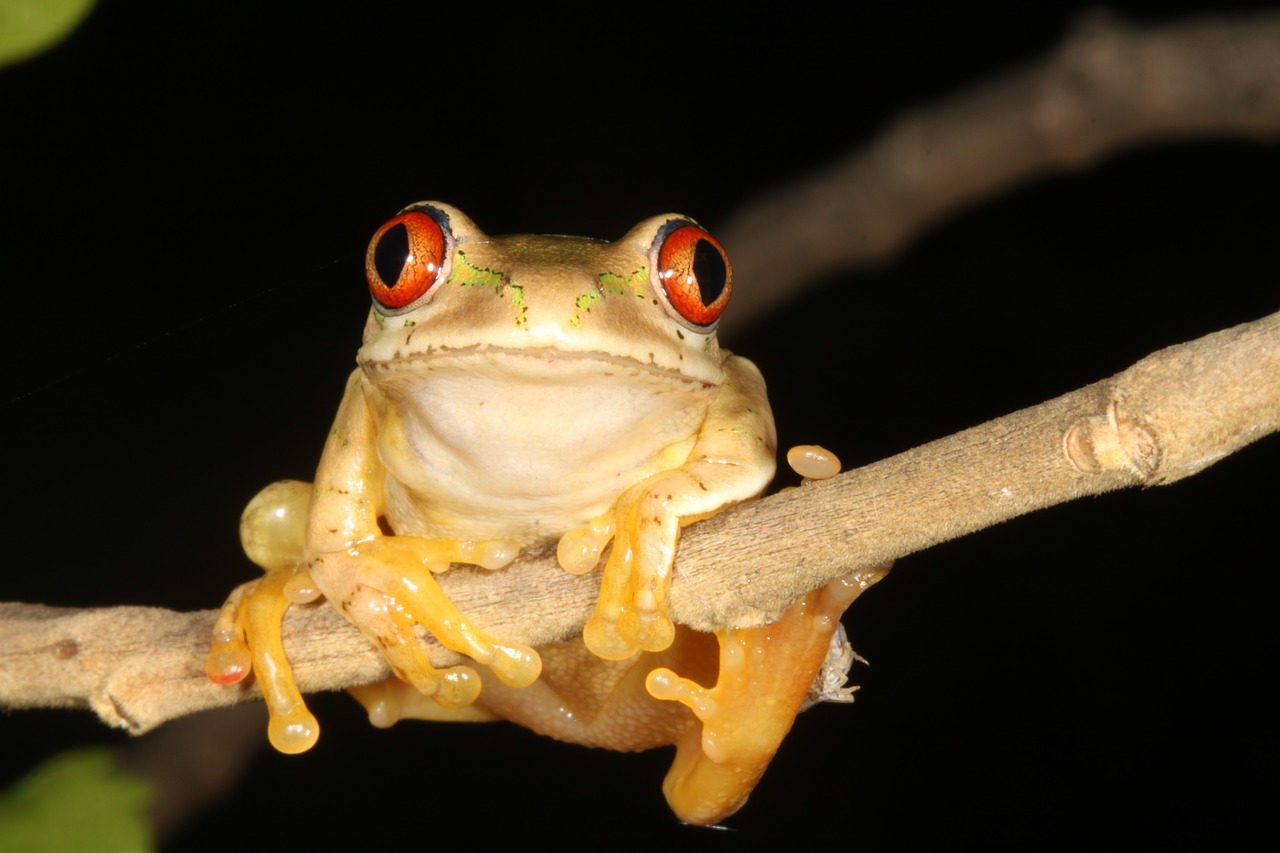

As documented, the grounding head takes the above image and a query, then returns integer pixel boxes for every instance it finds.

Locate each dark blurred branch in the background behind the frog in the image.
[716,10,1280,334]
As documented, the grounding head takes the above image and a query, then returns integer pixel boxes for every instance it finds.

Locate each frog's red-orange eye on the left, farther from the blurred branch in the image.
[365,209,447,310]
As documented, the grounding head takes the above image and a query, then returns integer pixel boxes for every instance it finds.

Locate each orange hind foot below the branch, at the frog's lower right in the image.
[645,575,879,824]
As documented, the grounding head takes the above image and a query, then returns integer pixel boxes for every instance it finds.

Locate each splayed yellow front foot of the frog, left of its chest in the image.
[320,537,541,708]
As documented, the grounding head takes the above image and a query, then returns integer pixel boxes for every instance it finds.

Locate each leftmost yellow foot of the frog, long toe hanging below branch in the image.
[205,570,320,754]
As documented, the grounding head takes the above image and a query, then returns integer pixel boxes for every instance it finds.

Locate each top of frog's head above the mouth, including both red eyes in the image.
[358,201,732,386]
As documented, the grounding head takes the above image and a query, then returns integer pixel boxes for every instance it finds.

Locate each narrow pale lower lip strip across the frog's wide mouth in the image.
[357,346,724,388]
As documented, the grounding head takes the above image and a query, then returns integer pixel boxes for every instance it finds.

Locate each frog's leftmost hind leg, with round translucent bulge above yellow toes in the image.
[205,480,320,753]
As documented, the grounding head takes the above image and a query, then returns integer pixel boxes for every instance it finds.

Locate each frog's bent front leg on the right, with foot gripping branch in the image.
[558,356,777,660]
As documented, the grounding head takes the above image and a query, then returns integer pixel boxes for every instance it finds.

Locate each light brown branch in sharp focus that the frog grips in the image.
[0,308,1280,733]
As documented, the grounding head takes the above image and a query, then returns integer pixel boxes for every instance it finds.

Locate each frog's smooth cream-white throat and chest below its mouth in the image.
[369,352,716,544]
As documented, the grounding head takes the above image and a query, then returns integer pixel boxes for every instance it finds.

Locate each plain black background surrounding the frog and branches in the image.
[0,1,1280,849]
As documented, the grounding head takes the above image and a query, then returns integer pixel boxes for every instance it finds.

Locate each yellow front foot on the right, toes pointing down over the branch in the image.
[576,471,692,661]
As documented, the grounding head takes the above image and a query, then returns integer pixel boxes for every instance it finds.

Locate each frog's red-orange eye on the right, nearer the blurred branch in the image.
[655,220,733,332]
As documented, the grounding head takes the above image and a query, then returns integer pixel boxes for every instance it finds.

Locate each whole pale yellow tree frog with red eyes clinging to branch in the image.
[207,201,880,824]
